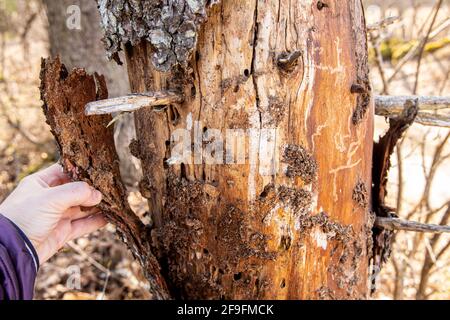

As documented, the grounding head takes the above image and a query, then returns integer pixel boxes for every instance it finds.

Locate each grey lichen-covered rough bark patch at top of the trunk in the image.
[97,0,218,72]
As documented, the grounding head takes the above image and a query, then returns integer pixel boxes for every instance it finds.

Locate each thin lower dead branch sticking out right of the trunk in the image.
[375,217,450,233]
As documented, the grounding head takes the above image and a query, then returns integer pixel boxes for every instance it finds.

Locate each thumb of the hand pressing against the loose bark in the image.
[46,182,102,211]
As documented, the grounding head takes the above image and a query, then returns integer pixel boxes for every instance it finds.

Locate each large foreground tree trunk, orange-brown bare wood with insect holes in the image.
[113,0,373,299]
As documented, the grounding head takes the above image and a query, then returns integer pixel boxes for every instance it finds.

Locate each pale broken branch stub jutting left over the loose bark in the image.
[84,91,184,116]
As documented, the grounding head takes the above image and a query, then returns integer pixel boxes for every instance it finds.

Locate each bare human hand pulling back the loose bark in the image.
[0,164,106,264]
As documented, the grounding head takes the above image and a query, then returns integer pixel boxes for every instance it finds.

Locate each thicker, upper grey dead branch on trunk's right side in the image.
[375,96,450,127]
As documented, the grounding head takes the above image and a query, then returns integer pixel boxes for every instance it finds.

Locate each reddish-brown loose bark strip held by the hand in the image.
[40,58,169,299]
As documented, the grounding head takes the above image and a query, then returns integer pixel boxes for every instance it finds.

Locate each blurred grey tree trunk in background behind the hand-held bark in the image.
[43,0,142,186]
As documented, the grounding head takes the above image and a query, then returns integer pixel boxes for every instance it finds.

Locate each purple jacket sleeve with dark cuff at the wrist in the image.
[0,214,39,300]
